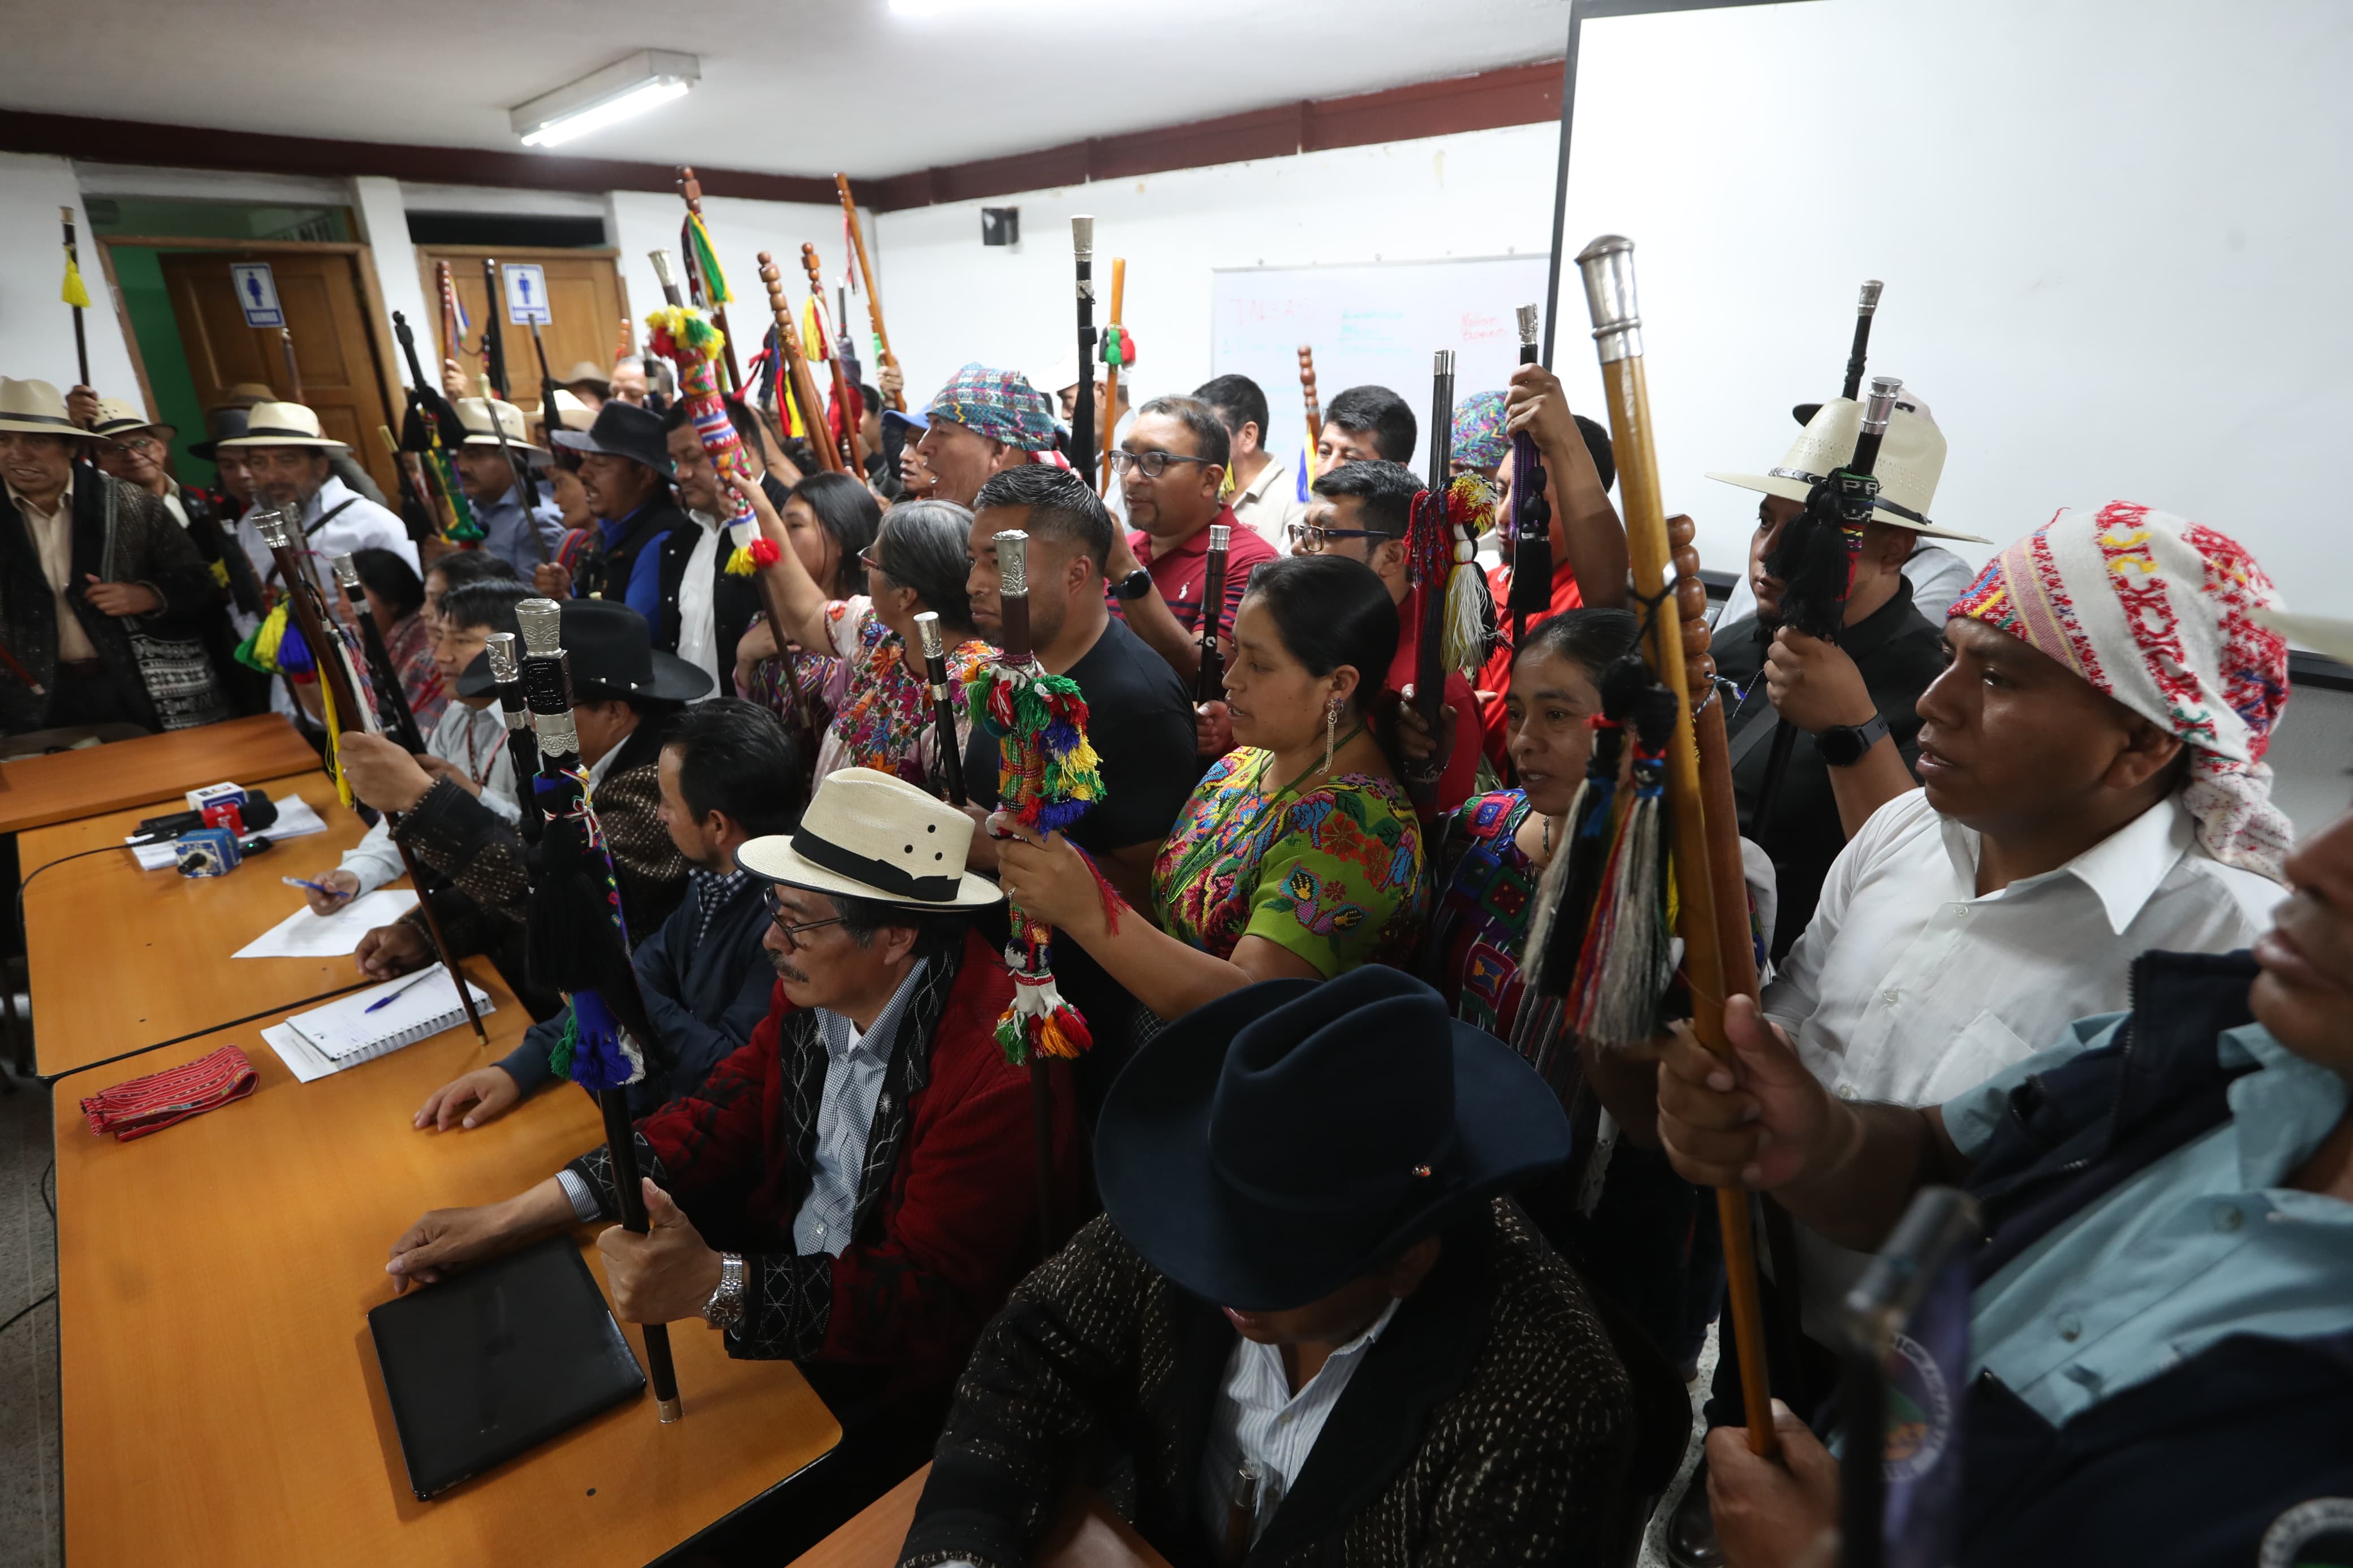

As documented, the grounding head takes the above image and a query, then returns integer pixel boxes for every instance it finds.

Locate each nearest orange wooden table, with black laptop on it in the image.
[50,973,840,1568]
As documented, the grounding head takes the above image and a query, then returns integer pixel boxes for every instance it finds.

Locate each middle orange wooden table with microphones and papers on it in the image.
[10,771,378,1081]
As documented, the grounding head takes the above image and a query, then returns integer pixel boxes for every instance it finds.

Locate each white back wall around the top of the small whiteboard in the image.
[870,124,1576,416]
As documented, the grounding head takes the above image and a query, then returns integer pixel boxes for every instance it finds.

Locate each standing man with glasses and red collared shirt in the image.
[1106,398,1275,684]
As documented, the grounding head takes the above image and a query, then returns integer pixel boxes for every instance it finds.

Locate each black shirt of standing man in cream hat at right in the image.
[1710,578,1943,959]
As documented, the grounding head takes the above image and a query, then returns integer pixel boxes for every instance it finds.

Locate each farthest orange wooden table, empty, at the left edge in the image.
[0,712,318,841]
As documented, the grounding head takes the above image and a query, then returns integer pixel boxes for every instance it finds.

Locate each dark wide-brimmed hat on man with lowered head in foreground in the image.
[1094,964,1570,1312]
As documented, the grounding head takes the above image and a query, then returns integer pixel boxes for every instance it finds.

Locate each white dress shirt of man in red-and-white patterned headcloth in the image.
[1762,790,2285,1340]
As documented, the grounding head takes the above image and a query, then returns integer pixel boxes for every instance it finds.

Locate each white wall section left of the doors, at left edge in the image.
[0,153,139,395]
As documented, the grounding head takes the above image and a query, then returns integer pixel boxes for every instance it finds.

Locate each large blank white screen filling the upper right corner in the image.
[1555,0,2353,616]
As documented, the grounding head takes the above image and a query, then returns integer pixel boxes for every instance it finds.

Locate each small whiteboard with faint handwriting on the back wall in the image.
[1209,254,1550,470]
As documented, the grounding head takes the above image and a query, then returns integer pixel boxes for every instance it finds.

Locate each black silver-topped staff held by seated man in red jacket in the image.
[515,599,682,1424]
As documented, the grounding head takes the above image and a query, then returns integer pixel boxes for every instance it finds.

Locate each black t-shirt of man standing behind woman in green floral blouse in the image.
[965,621,1207,1119]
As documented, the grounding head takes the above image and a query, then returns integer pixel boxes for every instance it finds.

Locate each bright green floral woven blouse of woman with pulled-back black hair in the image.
[1153,745,1421,980]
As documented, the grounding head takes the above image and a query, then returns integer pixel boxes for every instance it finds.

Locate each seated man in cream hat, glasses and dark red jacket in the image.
[386,768,1078,1505]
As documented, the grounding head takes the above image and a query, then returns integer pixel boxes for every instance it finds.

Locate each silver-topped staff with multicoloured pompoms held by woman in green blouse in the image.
[965,529,1104,1255]
